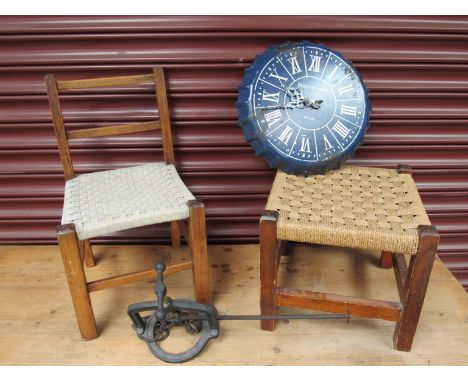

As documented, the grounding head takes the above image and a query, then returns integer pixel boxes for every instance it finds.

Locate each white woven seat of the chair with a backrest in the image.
[62,163,195,240]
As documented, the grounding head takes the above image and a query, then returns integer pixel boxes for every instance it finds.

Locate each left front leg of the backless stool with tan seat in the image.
[260,211,278,331]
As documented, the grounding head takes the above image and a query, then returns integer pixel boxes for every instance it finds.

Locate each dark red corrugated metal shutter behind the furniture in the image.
[0,16,468,287]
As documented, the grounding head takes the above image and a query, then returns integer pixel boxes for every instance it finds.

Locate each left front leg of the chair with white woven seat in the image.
[57,224,98,340]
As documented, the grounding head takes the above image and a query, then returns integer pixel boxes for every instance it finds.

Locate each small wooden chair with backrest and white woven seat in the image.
[45,68,210,339]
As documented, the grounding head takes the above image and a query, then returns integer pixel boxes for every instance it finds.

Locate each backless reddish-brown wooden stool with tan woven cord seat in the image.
[260,166,439,351]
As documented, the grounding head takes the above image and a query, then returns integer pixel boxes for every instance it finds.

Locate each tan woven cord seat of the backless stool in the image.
[266,166,430,254]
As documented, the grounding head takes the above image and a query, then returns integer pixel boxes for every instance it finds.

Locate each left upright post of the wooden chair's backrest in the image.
[45,74,75,180]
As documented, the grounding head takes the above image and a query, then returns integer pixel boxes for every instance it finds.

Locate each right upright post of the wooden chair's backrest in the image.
[153,68,174,164]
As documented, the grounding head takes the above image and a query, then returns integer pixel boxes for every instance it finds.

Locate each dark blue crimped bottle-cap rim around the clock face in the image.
[236,40,372,176]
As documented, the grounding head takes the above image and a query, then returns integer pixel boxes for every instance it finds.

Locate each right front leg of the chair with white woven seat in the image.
[188,200,210,304]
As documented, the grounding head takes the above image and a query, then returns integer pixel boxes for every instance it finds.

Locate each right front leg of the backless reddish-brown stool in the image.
[393,226,439,351]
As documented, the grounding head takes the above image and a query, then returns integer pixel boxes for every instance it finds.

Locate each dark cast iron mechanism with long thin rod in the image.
[128,262,349,363]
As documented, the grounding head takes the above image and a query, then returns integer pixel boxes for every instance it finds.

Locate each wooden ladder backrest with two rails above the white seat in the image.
[45,67,174,180]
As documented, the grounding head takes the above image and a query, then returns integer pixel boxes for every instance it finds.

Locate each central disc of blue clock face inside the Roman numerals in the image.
[286,77,336,130]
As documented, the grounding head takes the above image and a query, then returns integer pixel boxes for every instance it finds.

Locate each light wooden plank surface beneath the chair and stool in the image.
[0,245,468,365]
